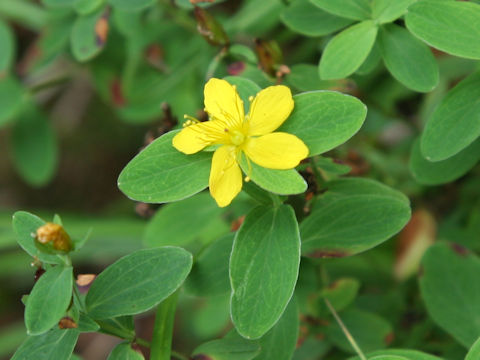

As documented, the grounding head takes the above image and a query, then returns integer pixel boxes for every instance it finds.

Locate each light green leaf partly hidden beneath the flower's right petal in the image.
[240,156,307,195]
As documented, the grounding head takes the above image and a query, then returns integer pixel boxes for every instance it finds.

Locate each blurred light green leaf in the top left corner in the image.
[0,0,48,31]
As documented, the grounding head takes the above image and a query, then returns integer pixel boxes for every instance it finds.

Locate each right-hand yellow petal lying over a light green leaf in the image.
[243,132,308,169]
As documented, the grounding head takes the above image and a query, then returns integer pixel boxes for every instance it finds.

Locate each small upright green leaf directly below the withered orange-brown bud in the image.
[25,265,73,335]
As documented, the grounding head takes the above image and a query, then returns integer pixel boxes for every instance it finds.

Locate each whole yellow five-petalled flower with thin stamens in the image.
[173,79,308,207]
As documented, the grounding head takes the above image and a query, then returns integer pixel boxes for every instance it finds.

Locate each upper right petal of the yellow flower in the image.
[248,85,293,136]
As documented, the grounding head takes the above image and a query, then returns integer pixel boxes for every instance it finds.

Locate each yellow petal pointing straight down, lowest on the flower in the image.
[209,145,242,207]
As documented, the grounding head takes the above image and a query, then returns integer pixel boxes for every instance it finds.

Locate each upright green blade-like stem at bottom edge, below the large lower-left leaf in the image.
[150,292,178,360]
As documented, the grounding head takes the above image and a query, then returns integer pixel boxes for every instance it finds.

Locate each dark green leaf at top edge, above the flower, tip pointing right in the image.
[281,0,353,36]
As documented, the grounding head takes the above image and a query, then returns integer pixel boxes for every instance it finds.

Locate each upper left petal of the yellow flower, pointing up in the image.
[204,78,245,128]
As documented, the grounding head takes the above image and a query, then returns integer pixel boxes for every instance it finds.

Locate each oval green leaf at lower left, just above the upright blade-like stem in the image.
[85,247,192,319]
